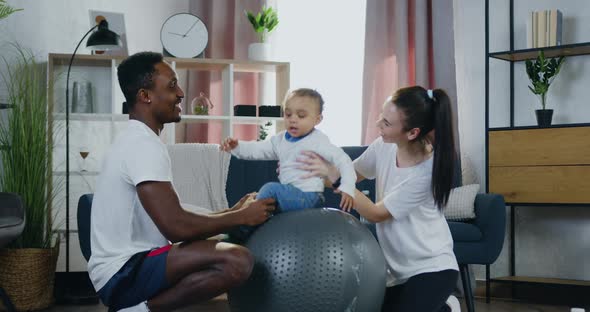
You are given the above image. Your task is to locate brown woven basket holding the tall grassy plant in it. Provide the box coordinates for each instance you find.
[0,244,59,311]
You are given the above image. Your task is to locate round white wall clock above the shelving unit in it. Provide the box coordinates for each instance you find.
[160,13,209,58]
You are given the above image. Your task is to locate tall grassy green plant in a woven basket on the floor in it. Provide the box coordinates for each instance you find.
[0,45,59,311]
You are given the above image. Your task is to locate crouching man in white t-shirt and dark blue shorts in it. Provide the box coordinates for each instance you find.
[88,52,274,311]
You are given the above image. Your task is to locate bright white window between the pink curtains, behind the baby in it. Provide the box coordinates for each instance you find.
[270,0,366,146]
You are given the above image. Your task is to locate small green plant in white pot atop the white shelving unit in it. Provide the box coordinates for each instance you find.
[244,6,279,61]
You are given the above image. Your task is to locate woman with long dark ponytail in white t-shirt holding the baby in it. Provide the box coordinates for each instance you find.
[301,86,458,312]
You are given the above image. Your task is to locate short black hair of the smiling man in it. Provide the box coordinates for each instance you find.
[117,52,164,109]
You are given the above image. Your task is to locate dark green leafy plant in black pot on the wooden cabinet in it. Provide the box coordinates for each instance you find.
[525,50,565,127]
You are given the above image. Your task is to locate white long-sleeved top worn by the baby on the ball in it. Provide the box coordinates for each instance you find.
[232,129,356,198]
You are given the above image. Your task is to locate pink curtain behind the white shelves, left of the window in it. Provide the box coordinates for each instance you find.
[180,0,264,143]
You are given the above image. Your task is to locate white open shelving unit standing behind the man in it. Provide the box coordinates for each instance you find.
[48,54,289,271]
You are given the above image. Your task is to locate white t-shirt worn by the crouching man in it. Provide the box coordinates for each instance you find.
[88,120,172,290]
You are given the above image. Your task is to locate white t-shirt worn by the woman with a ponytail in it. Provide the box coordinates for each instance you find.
[354,137,458,286]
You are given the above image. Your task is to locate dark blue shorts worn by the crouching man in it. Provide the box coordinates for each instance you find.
[98,245,172,311]
